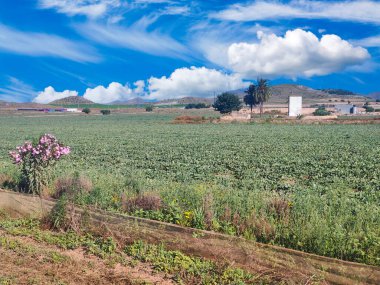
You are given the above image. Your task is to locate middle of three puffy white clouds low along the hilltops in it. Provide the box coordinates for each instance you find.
[83,80,145,104]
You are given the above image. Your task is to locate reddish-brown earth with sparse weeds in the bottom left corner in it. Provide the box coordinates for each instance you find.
[0,230,173,285]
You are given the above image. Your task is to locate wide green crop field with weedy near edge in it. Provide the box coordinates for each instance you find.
[0,114,380,265]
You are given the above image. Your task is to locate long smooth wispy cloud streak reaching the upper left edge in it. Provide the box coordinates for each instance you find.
[0,24,99,62]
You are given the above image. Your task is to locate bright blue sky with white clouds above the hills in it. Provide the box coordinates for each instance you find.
[0,0,380,104]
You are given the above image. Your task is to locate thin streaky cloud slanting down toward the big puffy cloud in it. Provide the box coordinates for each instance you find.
[77,22,189,59]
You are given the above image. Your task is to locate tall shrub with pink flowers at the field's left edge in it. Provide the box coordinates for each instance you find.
[9,134,70,194]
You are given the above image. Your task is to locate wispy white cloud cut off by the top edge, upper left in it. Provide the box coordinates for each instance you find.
[39,0,121,18]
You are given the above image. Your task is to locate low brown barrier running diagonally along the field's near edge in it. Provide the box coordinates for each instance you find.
[0,190,380,285]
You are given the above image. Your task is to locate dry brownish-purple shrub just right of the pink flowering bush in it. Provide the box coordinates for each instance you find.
[52,173,92,199]
